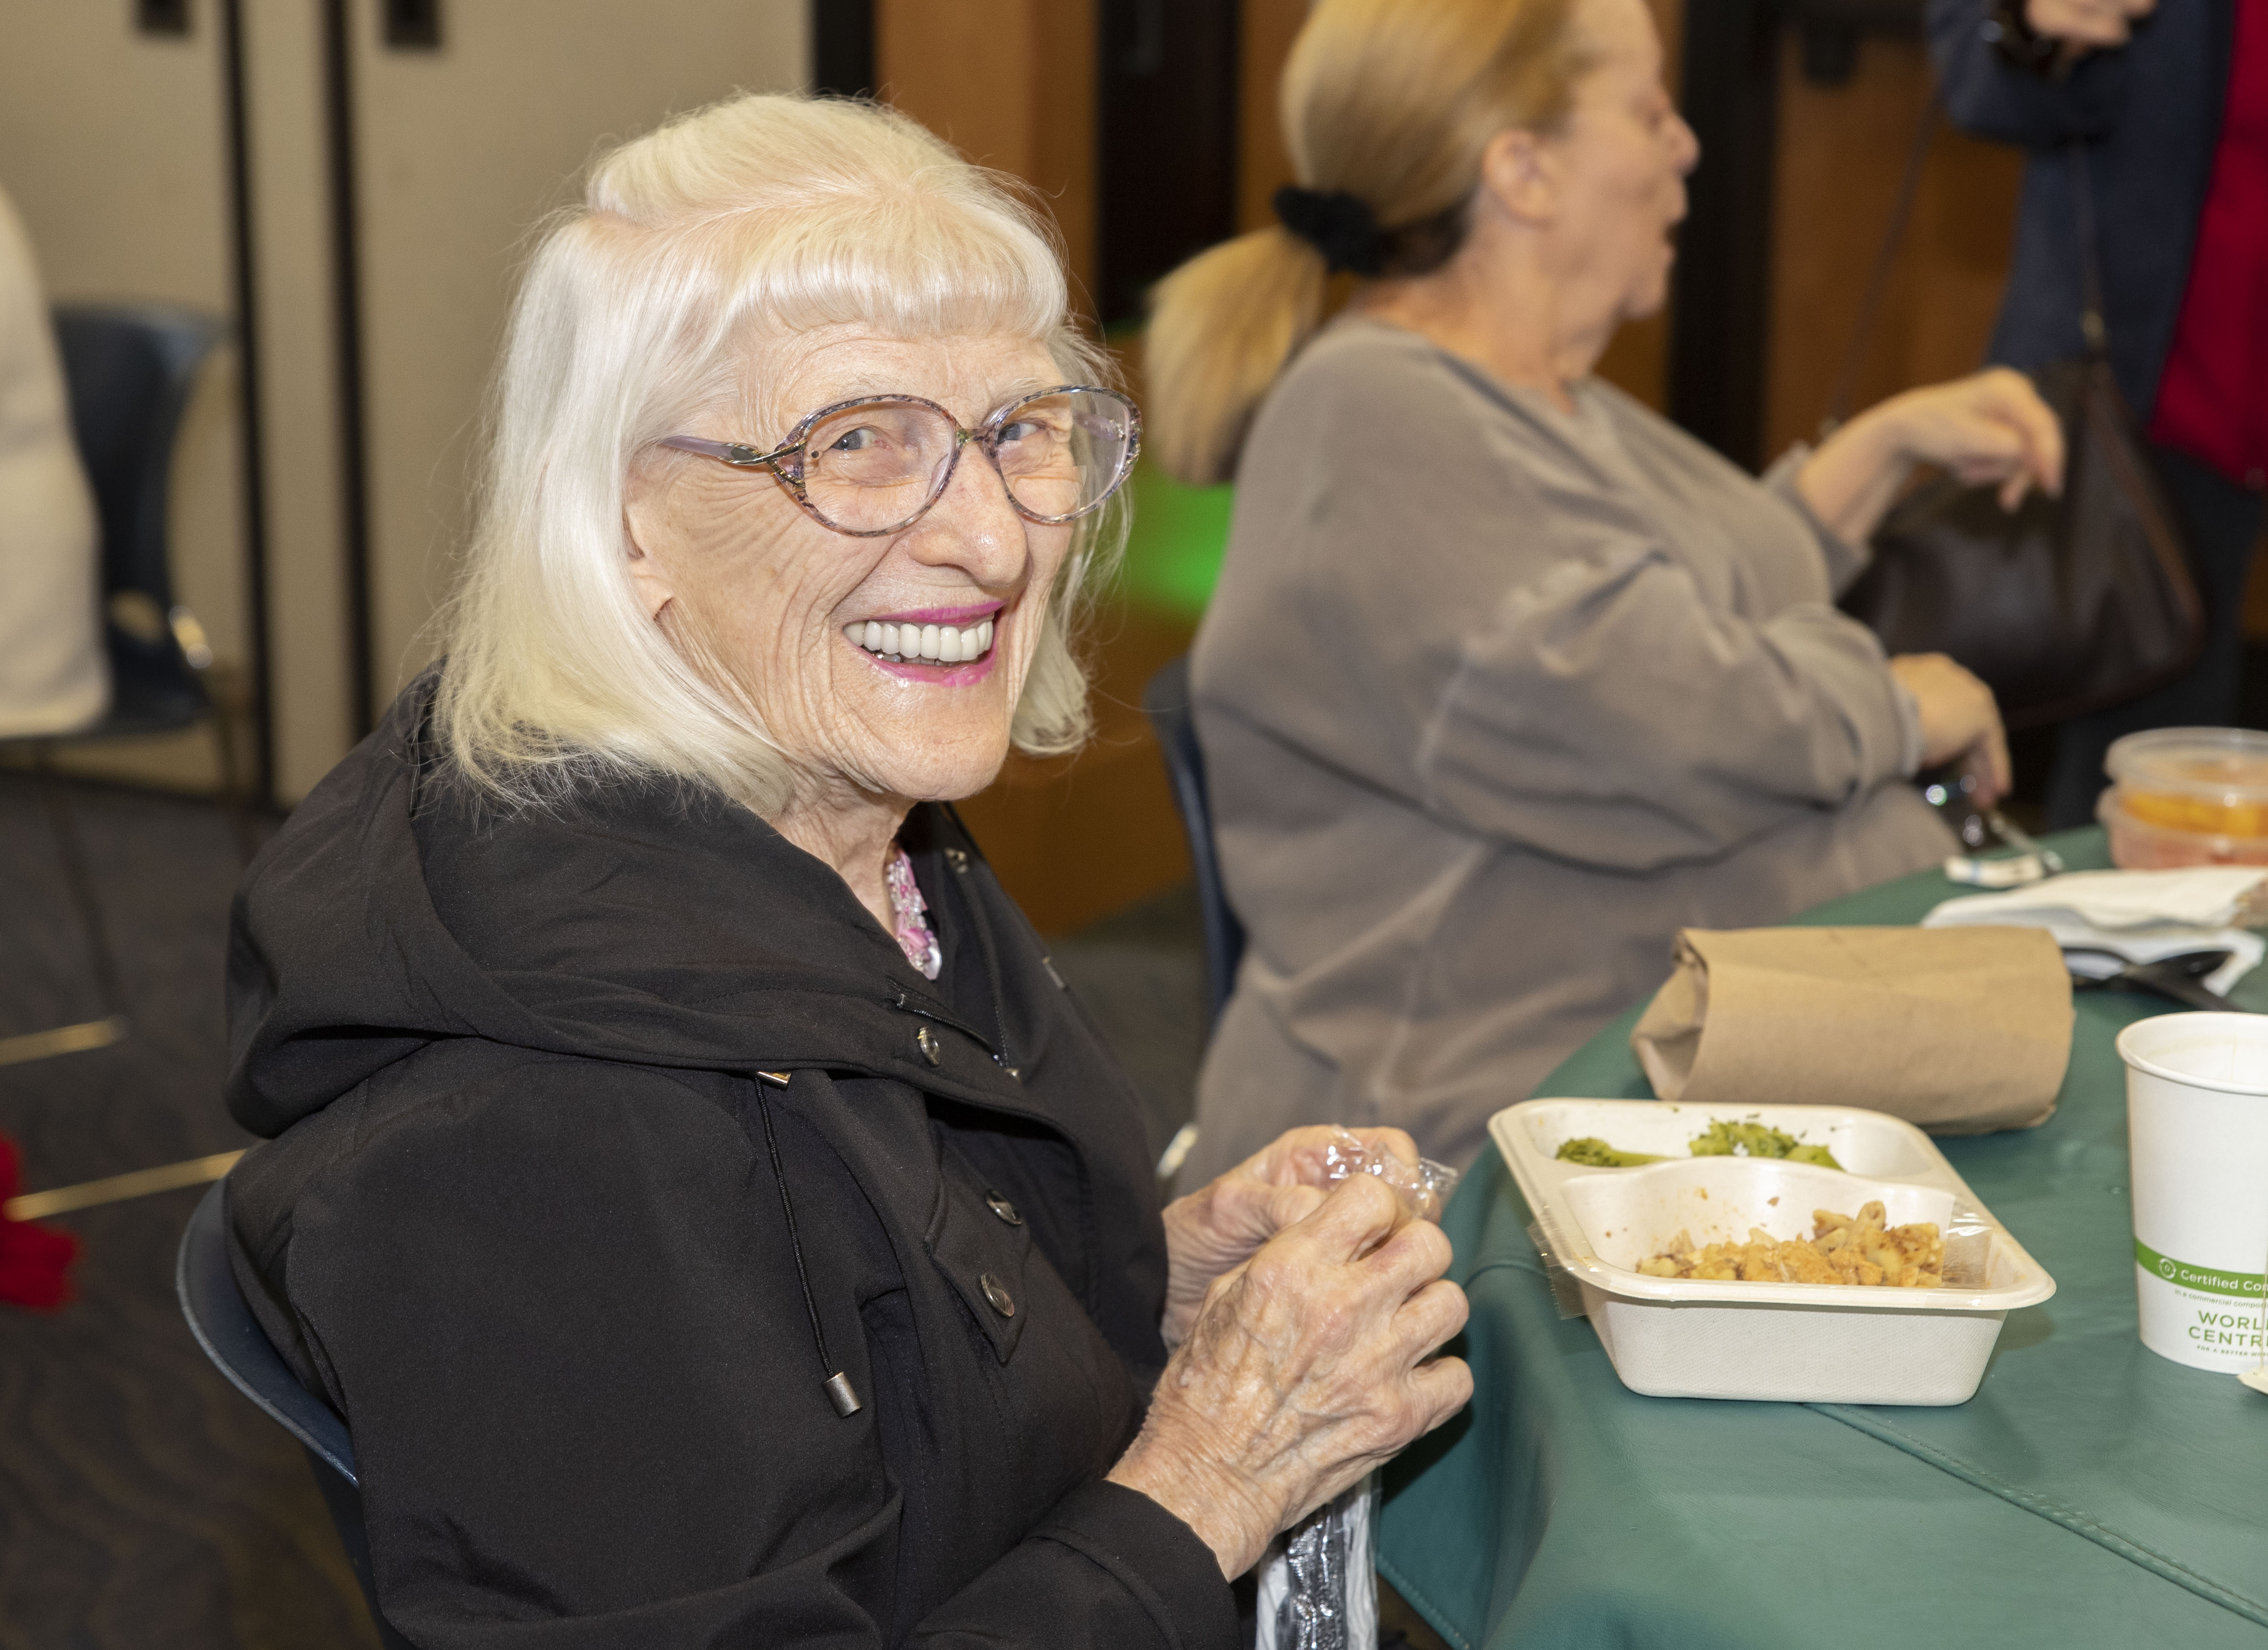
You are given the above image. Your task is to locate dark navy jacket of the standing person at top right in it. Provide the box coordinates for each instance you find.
[1930,0,2236,426]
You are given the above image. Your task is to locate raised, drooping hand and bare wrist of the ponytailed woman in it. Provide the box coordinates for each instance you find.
[1796,367,2064,544]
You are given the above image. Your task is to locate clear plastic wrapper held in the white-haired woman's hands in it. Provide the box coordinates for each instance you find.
[1254,1128,1456,1650]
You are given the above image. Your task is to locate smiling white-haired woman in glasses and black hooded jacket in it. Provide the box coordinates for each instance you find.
[229,97,1470,1650]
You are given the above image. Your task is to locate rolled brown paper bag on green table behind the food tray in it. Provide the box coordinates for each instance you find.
[1631,927,2071,1133]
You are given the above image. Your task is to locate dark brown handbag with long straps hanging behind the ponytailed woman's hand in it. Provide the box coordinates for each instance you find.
[1826,113,2205,730]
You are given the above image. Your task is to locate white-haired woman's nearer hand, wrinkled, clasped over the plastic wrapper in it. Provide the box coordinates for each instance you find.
[1111,1179,1472,1580]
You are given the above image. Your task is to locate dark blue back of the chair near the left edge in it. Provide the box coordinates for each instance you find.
[54,304,227,732]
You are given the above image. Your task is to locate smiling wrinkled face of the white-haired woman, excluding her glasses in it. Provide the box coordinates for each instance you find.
[626,329,1075,800]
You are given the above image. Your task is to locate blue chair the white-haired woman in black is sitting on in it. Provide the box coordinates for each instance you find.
[172,1181,415,1650]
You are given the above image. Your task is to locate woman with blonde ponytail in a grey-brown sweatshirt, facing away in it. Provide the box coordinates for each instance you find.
[1150,0,2062,1181]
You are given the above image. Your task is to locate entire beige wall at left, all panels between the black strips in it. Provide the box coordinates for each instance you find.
[0,0,823,800]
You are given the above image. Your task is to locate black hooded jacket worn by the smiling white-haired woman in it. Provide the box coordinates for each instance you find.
[229,678,1236,1650]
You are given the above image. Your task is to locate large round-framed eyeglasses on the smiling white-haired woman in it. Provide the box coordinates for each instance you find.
[660,383,1141,539]
